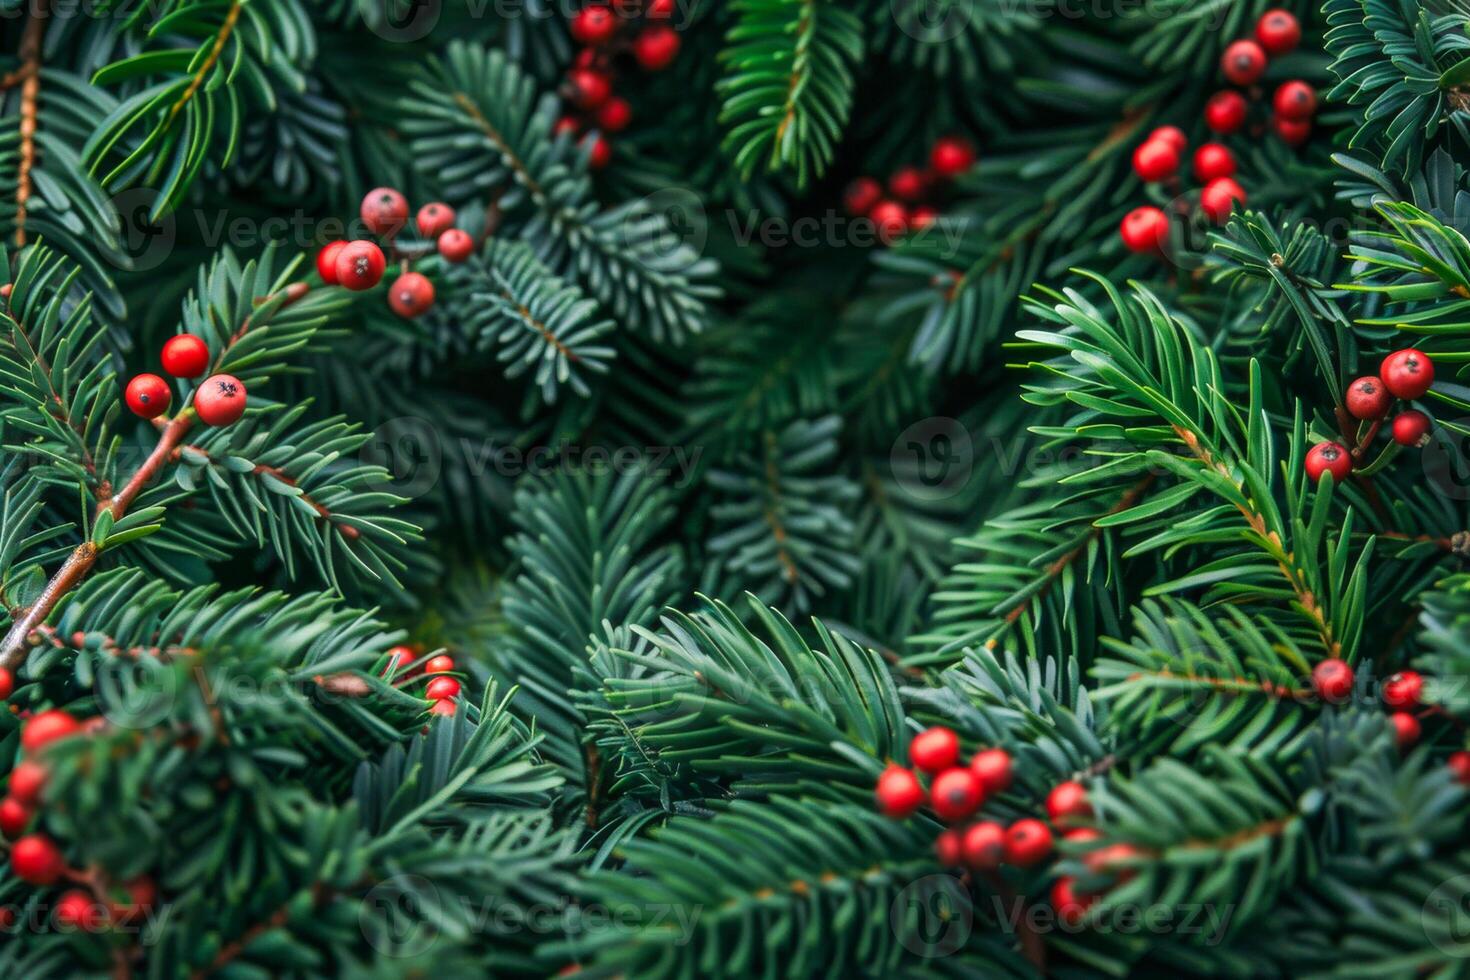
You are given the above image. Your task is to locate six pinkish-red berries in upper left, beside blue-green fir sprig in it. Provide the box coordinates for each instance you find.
[316,187,475,319]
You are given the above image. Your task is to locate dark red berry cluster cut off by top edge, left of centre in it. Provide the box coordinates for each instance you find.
[556,0,681,170]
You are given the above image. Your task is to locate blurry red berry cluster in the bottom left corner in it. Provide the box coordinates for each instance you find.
[0,710,157,932]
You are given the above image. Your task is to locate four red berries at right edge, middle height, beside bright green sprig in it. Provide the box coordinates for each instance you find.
[1305,348,1435,483]
